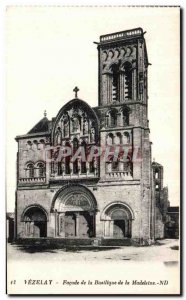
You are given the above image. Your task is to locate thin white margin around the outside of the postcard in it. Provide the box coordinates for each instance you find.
[0,0,186,299]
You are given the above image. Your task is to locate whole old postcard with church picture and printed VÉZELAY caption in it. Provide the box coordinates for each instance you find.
[5,6,181,295]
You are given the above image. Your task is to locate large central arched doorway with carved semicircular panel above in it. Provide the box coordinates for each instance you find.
[52,185,97,238]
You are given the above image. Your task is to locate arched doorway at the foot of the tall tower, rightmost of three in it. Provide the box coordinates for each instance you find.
[101,202,133,239]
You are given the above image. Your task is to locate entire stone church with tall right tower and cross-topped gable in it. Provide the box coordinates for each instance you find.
[15,28,168,244]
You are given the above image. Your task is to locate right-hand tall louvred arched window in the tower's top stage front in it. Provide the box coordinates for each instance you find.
[123,62,132,99]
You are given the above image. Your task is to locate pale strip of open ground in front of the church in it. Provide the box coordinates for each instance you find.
[7,239,179,264]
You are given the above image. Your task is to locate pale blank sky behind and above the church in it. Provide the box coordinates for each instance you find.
[5,6,180,211]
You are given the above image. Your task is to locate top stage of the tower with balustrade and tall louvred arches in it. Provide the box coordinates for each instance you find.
[98,28,148,106]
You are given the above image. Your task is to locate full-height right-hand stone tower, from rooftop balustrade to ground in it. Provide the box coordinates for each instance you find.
[96,28,154,240]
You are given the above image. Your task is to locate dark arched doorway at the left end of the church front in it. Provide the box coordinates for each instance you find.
[22,206,47,238]
